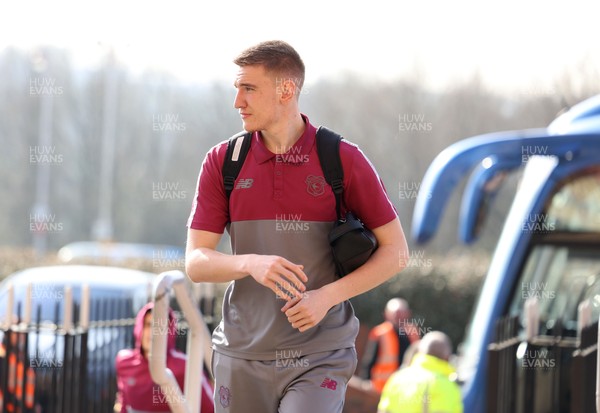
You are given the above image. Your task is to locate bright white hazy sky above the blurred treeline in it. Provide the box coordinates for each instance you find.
[0,0,600,90]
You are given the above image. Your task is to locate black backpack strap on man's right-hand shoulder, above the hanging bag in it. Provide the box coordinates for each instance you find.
[316,126,344,219]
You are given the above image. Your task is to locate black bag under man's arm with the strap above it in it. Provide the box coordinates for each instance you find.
[317,126,377,277]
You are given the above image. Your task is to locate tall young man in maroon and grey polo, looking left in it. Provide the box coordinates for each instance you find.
[186,41,408,413]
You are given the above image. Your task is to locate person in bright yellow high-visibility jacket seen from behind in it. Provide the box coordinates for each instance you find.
[377,331,463,413]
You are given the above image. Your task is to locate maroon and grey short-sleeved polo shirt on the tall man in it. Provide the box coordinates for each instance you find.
[188,115,397,360]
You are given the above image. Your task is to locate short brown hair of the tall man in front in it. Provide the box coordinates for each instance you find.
[233,40,305,89]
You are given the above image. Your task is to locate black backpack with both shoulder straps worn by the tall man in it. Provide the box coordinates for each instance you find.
[222,126,377,277]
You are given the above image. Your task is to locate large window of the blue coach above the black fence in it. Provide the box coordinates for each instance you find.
[509,169,600,336]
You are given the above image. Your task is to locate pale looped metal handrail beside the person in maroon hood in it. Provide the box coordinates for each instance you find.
[149,271,210,413]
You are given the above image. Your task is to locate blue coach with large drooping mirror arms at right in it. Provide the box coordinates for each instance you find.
[412,95,600,413]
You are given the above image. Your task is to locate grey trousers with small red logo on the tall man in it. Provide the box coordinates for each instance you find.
[212,348,357,413]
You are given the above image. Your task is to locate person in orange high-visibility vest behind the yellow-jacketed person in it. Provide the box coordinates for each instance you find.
[359,298,420,393]
